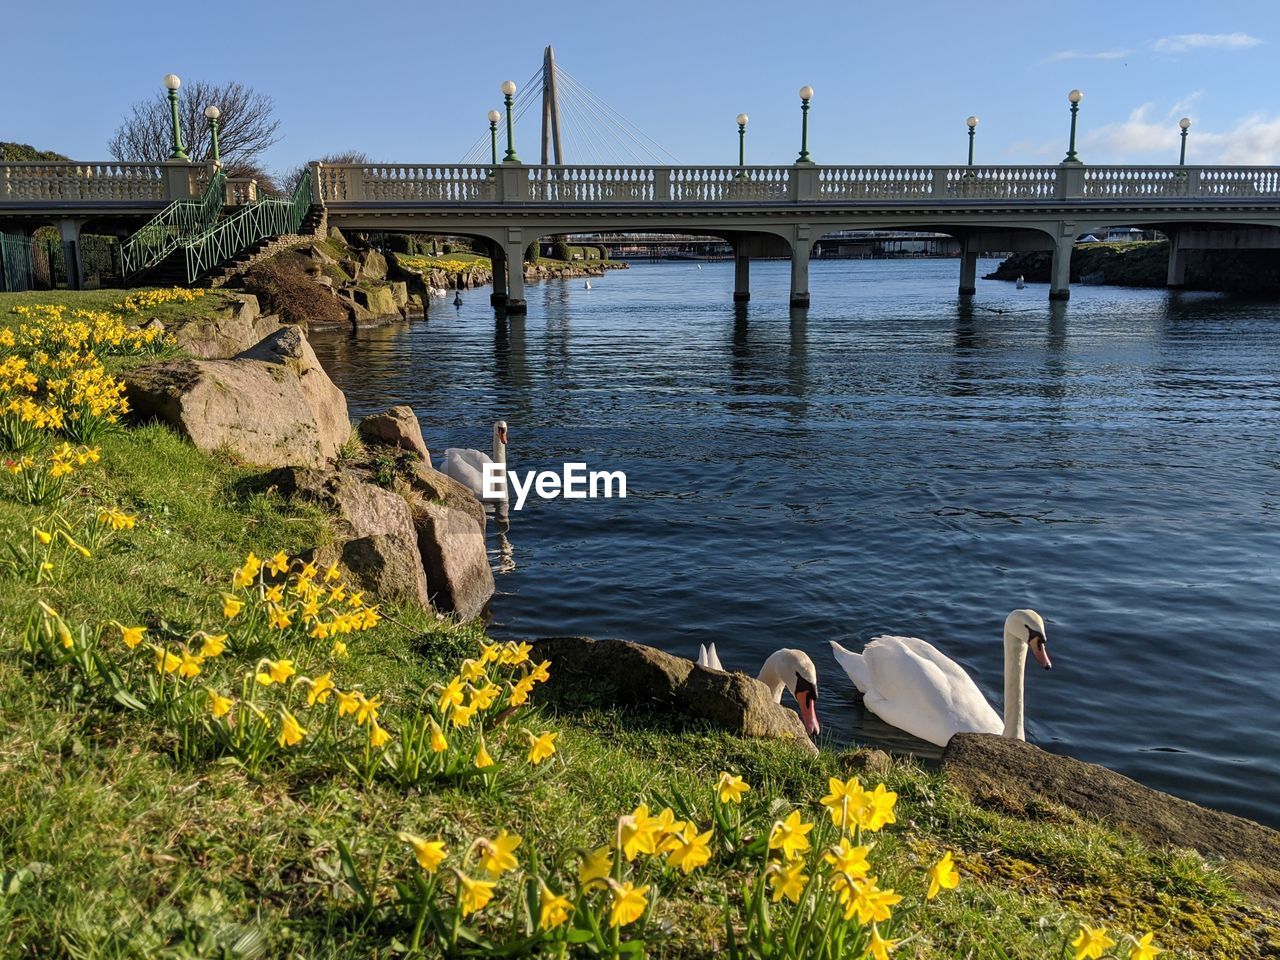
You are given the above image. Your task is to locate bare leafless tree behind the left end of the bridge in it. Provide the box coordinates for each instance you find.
[108,81,280,177]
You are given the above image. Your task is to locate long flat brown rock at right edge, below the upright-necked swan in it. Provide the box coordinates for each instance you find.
[942,733,1280,902]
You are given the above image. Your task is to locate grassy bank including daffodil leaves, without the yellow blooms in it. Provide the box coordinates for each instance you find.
[0,293,1280,959]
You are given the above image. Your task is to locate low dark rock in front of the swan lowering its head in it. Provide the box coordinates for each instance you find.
[534,636,817,753]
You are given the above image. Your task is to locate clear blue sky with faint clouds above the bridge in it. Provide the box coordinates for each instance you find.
[0,0,1280,169]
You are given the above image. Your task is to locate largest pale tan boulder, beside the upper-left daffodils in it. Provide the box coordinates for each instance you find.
[124,326,351,467]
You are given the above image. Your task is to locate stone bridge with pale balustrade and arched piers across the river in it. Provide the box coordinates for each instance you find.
[0,161,1280,314]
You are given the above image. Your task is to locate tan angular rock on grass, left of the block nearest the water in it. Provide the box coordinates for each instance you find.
[268,467,429,607]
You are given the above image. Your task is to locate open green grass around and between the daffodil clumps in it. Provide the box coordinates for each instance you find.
[0,294,1280,960]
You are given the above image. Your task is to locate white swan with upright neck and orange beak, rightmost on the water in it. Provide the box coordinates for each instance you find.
[831,611,1053,746]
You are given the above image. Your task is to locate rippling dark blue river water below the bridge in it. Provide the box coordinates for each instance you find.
[314,260,1280,826]
